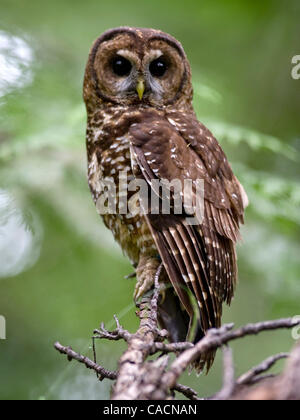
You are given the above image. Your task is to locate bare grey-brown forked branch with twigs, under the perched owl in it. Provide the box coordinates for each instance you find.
[55,265,300,400]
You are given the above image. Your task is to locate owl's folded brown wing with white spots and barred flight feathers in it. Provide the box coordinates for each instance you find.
[130,112,244,338]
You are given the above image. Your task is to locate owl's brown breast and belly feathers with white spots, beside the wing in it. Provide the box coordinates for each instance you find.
[86,107,158,265]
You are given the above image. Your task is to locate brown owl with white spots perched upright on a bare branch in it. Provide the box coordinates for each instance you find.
[83,27,247,370]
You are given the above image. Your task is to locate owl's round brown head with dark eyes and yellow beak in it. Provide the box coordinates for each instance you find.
[83,27,192,108]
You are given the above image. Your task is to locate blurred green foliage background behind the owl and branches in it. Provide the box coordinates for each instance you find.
[0,0,300,399]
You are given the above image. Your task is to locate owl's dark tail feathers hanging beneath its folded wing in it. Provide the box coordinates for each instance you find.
[158,287,216,374]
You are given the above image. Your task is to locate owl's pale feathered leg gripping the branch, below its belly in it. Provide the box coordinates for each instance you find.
[133,257,160,302]
